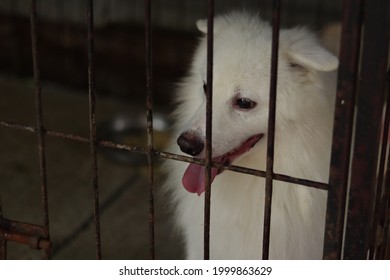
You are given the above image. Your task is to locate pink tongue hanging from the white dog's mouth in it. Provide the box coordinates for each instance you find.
[182,163,218,195]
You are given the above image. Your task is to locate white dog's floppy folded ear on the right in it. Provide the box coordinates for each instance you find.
[283,28,339,72]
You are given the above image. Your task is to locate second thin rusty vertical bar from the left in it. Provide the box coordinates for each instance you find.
[87,0,102,260]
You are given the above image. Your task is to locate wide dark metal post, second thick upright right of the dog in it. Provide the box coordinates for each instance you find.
[344,1,390,259]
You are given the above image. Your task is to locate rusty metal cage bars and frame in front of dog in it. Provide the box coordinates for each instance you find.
[0,0,390,259]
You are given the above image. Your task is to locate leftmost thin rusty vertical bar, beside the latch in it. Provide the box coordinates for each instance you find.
[30,0,51,259]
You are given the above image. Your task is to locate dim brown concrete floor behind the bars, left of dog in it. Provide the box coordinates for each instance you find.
[0,77,183,259]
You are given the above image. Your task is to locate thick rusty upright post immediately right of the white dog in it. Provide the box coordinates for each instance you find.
[323,0,364,259]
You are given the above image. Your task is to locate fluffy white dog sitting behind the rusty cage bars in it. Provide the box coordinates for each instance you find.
[167,12,338,259]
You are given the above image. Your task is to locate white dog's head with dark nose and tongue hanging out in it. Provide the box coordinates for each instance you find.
[177,13,338,194]
